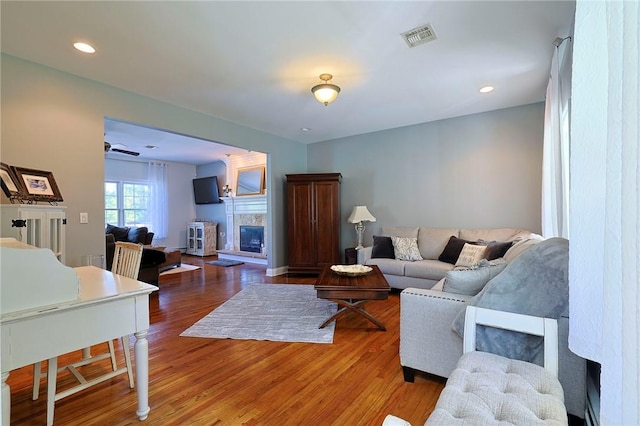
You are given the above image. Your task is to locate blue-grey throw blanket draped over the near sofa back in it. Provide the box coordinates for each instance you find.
[453,238,569,363]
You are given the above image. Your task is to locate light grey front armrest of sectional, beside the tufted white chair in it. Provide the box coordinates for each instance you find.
[400,288,472,377]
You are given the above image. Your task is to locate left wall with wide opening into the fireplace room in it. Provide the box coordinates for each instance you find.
[0,54,307,268]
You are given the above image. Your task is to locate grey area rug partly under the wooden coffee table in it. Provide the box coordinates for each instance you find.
[181,284,337,343]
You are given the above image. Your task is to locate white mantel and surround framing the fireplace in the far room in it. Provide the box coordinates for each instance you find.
[218,195,267,264]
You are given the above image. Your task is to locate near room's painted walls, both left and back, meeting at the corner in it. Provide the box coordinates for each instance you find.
[0,55,544,269]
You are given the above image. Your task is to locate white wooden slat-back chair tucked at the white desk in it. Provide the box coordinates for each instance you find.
[33,242,143,425]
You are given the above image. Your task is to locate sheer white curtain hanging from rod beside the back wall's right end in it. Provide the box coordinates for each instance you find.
[542,38,572,238]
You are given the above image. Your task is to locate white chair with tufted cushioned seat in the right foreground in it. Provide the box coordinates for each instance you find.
[425,306,568,426]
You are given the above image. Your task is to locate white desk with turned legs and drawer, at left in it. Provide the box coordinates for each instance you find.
[0,266,158,425]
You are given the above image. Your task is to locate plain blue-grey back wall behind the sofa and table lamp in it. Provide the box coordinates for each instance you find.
[307,103,544,247]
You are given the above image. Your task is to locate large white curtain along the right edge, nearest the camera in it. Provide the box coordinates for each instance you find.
[569,0,640,425]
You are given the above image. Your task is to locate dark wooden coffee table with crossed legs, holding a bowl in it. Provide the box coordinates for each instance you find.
[315,265,391,331]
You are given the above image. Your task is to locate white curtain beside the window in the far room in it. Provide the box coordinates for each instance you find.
[147,161,169,244]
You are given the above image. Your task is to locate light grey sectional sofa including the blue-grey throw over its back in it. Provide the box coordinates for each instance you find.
[358,227,586,418]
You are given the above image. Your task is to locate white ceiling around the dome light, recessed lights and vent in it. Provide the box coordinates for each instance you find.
[0,0,575,165]
